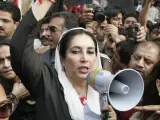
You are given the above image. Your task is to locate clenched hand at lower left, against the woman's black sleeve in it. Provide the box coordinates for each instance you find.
[12,83,30,100]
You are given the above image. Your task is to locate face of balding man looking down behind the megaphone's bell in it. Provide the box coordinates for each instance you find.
[129,46,159,78]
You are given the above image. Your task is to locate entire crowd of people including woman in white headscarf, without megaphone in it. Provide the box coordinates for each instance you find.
[0,0,160,120]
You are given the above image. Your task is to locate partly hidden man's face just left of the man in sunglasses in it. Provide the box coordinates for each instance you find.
[40,23,50,46]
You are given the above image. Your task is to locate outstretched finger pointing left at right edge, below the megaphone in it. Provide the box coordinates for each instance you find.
[135,105,160,111]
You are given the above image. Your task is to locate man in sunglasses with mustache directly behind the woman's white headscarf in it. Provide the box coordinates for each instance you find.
[41,12,79,65]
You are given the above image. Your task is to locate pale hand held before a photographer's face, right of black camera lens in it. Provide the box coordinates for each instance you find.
[104,24,120,43]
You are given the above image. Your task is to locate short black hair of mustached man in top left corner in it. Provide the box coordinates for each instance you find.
[0,1,21,22]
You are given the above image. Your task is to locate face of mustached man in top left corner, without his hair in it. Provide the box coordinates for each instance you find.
[0,10,18,38]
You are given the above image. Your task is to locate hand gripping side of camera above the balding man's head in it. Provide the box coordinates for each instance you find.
[136,26,146,42]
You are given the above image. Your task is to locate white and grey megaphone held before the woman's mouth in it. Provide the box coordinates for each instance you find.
[86,69,144,111]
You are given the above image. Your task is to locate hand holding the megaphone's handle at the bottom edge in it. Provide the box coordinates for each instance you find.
[101,105,117,120]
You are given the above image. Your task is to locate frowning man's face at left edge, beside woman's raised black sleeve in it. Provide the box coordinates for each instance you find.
[0,45,16,80]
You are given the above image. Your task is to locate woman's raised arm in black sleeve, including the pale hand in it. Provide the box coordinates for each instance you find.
[10,0,52,94]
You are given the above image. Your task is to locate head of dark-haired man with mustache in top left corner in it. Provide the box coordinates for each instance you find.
[0,1,21,39]
